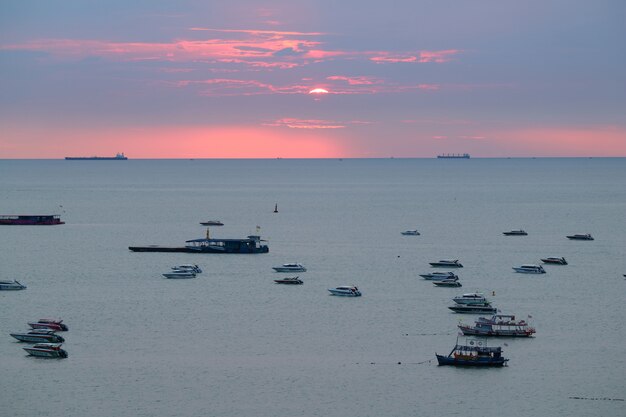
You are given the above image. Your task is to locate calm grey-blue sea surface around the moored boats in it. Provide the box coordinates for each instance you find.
[0,158,626,417]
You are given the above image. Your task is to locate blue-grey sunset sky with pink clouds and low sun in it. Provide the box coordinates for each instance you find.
[0,0,626,159]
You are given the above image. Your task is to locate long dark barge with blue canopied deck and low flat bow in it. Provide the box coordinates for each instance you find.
[128,235,269,253]
